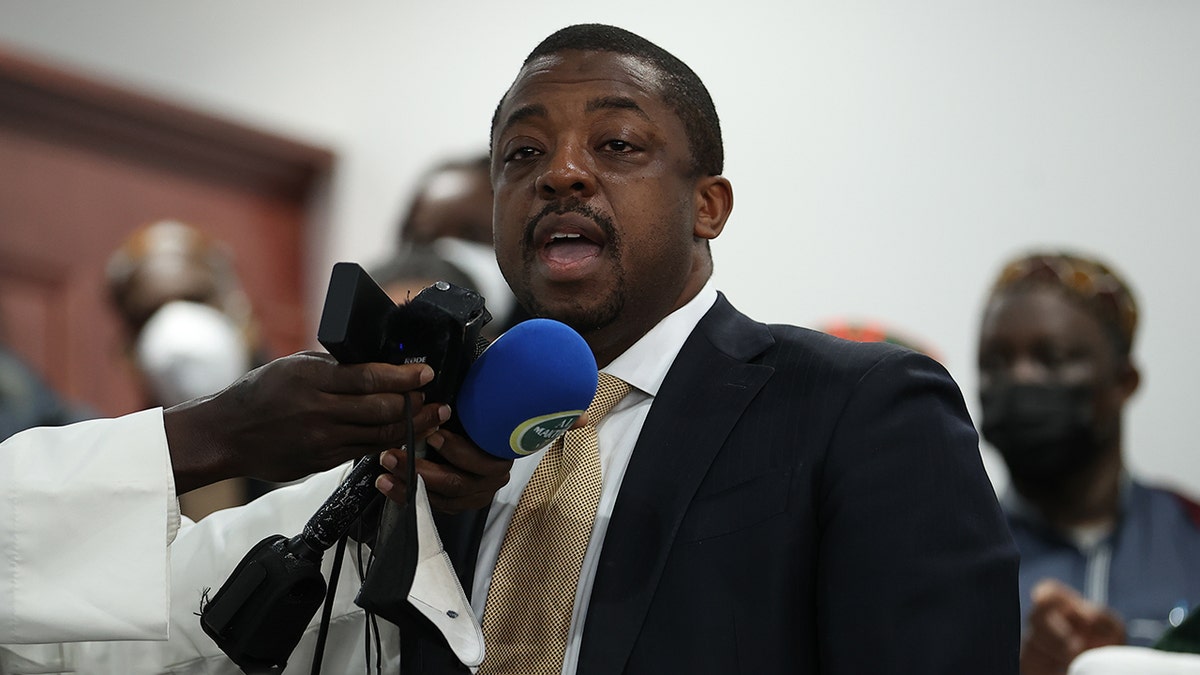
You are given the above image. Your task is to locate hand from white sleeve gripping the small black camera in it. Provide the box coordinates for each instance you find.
[163,352,449,494]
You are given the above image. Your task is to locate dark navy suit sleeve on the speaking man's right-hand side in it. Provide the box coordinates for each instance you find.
[816,352,1020,675]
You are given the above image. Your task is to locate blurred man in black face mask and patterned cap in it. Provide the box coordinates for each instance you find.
[978,253,1200,675]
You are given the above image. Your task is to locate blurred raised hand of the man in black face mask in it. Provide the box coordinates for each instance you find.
[1021,579,1126,675]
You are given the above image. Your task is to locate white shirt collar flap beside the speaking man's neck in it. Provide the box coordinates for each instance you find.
[601,279,716,396]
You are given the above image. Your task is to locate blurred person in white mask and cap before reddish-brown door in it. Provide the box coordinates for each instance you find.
[106,220,268,519]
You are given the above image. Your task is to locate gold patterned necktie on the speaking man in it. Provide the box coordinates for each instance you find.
[479,372,630,675]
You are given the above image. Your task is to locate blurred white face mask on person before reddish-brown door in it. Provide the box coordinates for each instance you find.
[134,300,250,407]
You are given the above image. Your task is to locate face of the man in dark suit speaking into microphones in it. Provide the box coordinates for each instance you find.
[492,50,724,362]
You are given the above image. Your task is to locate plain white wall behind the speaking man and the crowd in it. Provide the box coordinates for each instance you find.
[0,0,1200,494]
